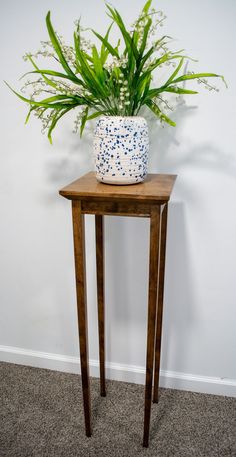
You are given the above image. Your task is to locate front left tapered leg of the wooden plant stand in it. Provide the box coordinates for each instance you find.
[72,200,91,436]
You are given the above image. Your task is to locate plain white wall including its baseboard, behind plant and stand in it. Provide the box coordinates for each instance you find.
[0,0,236,395]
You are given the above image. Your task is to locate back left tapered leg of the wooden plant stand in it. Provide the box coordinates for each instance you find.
[95,215,106,397]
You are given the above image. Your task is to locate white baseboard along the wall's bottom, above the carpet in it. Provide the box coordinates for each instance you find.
[0,346,236,397]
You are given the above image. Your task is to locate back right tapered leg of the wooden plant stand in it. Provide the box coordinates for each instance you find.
[153,203,168,403]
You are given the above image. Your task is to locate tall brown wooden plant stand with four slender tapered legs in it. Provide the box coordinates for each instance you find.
[59,172,176,447]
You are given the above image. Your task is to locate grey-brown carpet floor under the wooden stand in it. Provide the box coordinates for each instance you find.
[0,363,236,457]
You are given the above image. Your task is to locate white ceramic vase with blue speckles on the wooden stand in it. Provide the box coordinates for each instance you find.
[94,116,149,185]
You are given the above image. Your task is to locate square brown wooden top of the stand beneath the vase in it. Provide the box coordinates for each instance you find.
[59,171,177,202]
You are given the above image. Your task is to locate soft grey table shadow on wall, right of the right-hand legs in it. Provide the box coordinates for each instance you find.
[162,202,197,371]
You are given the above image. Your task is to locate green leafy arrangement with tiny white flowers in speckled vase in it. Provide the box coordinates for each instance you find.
[6,0,224,142]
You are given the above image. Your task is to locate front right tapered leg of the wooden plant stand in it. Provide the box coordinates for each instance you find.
[143,206,160,447]
